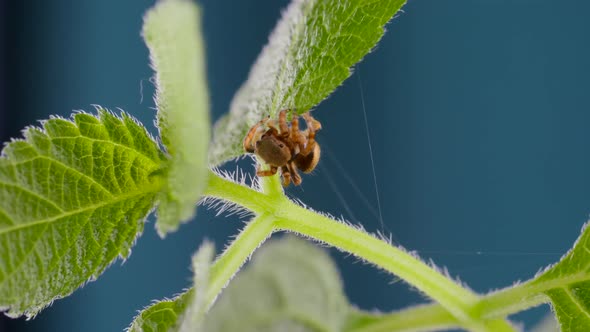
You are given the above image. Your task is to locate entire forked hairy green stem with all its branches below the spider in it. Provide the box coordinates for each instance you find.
[205,174,514,332]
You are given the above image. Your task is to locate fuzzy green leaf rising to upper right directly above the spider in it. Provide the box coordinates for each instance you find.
[209,0,405,165]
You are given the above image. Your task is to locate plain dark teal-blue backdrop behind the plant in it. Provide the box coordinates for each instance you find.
[0,0,590,331]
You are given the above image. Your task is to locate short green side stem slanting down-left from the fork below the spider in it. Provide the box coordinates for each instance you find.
[205,215,274,307]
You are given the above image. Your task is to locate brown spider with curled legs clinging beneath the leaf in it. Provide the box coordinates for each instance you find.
[244,110,322,186]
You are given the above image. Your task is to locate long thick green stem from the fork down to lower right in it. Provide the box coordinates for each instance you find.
[275,199,513,332]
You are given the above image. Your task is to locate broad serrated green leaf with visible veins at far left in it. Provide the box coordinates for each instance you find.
[0,109,164,317]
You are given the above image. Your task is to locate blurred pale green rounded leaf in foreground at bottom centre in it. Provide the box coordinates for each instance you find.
[204,237,349,332]
